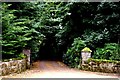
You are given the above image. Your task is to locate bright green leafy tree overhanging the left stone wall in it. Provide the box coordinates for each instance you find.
[2,3,44,58]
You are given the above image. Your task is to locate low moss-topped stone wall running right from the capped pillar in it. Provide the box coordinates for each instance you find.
[81,59,120,74]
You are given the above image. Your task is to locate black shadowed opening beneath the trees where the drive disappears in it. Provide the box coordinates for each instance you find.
[38,34,62,60]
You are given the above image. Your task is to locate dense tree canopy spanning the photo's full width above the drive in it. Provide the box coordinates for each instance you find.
[2,2,120,62]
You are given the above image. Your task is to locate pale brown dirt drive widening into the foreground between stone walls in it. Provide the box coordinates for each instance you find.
[2,61,119,78]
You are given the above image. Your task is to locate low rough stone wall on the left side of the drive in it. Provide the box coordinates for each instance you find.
[0,59,27,76]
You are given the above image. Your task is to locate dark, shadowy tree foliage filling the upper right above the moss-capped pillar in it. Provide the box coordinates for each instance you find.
[61,2,120,55]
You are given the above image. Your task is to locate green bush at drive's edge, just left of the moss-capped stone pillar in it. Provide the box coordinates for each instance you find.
[63,37,86,67]
